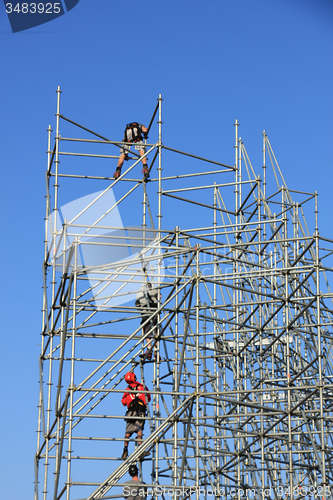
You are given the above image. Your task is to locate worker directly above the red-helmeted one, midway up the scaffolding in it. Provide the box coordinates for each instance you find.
[135,282,159,361]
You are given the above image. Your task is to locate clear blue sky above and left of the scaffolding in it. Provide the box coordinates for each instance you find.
[0,0,333,500]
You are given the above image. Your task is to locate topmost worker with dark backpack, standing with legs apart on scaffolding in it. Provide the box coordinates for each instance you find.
[113,122,149,179]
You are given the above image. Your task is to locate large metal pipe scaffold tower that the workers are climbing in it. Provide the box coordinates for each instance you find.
[35,88,333,500]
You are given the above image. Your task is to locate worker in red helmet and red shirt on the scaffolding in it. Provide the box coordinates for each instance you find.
[121,372,150,460]
